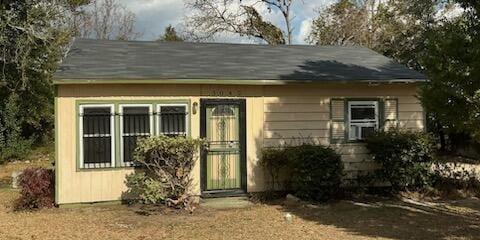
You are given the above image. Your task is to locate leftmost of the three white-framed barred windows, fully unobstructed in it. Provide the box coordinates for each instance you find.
[79,104,115,168]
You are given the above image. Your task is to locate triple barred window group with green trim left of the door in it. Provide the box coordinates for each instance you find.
[78,102,189,169]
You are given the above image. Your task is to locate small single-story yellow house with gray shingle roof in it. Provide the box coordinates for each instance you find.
[54,39,426,204]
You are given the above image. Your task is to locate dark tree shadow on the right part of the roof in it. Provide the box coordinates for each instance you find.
[280,59,422,80]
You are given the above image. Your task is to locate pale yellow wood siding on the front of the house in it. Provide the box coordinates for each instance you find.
[56,84,424,204]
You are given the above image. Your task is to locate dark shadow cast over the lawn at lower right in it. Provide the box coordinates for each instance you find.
[268,199,480,240]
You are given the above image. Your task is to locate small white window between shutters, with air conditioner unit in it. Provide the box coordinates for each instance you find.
[348,101,378,140]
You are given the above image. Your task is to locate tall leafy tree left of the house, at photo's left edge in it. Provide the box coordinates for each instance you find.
[0,0,76,162]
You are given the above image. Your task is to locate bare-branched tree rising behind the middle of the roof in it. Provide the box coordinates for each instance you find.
[185,0,294,44]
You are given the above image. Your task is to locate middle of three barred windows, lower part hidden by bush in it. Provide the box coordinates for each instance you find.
[120,104,153,166]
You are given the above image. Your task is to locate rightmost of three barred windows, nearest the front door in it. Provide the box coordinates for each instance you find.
[157,104,187,136]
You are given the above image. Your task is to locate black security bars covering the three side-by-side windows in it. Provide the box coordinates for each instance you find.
[80,106,188,169]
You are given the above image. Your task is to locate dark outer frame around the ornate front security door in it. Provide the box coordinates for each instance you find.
[200,98,247,197]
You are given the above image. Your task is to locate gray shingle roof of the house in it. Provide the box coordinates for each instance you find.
[54,39,425,82]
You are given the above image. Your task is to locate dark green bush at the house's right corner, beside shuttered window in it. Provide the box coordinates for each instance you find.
[366,129,434,191]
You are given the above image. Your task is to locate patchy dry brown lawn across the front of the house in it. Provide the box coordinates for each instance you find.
[0,190,480,240]
